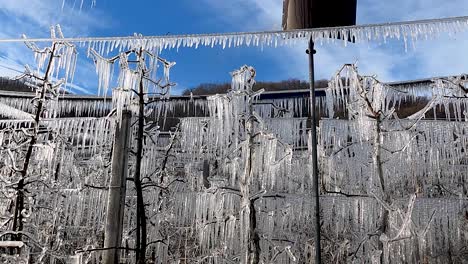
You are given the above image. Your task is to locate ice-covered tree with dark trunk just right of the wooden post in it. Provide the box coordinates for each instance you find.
[92,47,176,263]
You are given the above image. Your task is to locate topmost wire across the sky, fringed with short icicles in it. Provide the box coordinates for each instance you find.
[0,16,468,53]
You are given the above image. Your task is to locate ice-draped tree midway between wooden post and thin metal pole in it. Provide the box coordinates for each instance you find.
[181,66,310,263]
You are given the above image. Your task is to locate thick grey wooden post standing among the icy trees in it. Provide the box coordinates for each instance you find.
[103,111,132,264]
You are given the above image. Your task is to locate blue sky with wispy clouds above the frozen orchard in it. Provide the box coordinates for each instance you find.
[0,0,468,93]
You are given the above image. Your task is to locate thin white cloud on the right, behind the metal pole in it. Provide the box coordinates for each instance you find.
[203,0,468,81]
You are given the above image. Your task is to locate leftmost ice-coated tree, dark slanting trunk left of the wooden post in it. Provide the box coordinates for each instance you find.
[2,26,76,256]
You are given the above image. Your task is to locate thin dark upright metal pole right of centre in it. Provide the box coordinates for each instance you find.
[307,37,322,264]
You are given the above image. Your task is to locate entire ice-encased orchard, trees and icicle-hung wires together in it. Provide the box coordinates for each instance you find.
[0,8,468,264]
